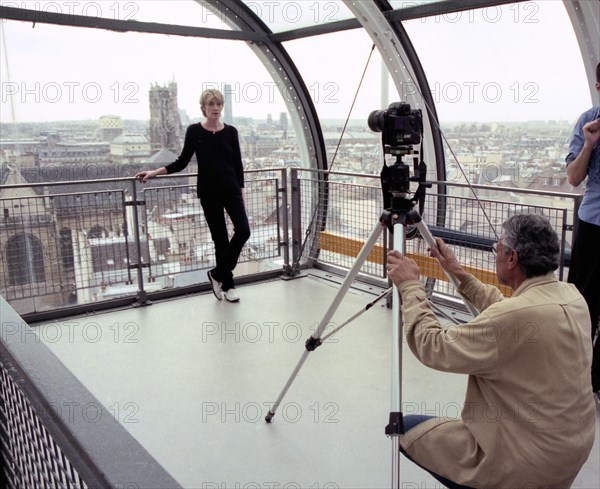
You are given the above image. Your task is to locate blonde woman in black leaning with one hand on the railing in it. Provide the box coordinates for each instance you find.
[135,89,250,302]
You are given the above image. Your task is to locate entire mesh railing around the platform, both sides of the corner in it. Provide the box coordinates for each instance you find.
[0,168,579,320]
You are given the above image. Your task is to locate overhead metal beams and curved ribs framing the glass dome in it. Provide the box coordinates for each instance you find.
[0,0,600,172]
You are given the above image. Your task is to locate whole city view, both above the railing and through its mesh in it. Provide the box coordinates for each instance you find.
[0,81,584,311]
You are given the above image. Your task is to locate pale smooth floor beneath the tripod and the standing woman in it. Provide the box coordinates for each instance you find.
[36,276,600,489]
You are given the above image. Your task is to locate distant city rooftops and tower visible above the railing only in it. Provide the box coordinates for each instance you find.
[0,82,584,193]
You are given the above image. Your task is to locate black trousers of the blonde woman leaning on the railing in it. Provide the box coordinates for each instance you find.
[200,193,250,290]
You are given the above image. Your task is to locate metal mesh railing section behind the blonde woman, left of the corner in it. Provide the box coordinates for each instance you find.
[0,169,289,320]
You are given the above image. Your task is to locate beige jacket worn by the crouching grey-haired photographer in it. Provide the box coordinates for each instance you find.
[399,273,595,489]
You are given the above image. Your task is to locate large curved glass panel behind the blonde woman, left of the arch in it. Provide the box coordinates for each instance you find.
[0,21,305,312]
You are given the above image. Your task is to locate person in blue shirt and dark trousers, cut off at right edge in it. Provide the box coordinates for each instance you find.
[565,63,600,399]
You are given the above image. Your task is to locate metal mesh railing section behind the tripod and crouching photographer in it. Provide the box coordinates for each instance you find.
[292,169,581,297]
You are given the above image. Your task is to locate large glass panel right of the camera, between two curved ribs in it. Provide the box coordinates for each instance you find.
[403,2,593,207]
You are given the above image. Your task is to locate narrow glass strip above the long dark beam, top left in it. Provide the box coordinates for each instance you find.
[3,0,229,29]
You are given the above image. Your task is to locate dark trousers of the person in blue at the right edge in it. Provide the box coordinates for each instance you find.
[568,221,600,392]
